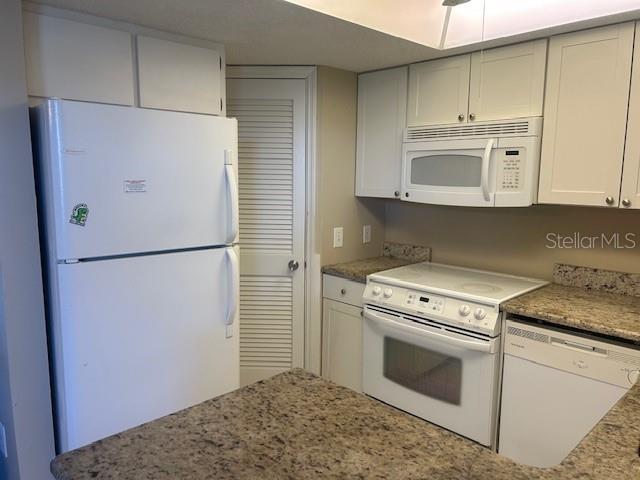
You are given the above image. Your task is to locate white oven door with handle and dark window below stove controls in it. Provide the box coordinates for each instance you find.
[363,306,499,446]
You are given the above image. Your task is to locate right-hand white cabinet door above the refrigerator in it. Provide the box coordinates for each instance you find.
[137,36,222,115]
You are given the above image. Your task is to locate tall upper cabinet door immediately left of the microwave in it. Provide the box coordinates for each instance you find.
[356,67,407,198]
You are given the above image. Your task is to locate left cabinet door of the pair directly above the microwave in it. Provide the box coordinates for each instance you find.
[407,55,471,127]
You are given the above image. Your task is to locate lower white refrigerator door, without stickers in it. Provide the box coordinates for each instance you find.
[52,248,239,451]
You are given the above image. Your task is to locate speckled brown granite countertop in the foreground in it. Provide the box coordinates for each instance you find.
[51,369,640,480]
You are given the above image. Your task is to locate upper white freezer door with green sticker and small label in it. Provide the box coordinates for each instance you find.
[42,100,237,260]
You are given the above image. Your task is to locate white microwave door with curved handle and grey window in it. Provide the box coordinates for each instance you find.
[401,138,498,207]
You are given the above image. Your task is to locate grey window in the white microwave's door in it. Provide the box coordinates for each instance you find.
[411,154,482,187]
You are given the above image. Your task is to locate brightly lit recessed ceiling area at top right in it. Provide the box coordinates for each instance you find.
[286,0,640,49]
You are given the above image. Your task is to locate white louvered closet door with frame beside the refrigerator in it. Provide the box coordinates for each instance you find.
[227,79,306,385]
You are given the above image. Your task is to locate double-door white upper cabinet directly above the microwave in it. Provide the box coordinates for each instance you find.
[407,39,547,127]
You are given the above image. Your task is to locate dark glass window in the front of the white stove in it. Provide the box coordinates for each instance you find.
[384,337,462,405]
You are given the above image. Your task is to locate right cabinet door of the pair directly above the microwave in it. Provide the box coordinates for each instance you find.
[469,39,547,121]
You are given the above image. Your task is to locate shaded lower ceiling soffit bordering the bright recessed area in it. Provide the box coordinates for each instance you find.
[27,0,637,72]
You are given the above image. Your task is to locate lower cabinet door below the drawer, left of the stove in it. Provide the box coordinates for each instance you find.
[322,298,362,392]
